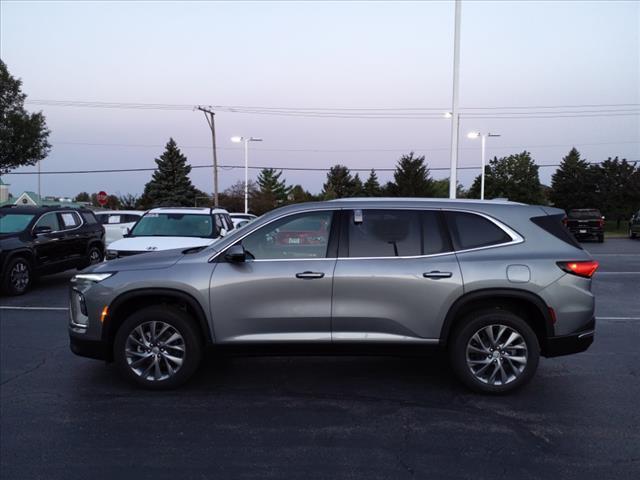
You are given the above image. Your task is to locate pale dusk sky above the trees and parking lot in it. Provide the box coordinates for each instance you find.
[0,0,640,196]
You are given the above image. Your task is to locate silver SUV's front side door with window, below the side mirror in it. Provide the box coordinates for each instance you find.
[210,210,337,343]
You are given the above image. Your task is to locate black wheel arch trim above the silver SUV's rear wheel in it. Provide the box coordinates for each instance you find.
[440,288,554,346]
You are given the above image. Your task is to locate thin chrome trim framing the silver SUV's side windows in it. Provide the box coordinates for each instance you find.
[208,206,524,262]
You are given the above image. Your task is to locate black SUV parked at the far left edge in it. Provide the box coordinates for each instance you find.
[0,205,104,295]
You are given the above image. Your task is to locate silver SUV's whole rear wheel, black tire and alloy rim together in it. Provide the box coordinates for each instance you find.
[449,309,540,394]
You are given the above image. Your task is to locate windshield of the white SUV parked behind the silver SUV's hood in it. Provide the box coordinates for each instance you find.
[130,213,217,238]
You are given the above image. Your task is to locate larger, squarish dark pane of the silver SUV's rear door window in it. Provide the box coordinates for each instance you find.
[348,210,422,257]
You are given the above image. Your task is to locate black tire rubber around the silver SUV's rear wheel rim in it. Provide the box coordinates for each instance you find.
[449,310,540,395]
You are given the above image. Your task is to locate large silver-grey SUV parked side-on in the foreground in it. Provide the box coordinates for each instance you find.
[69,199,598,393]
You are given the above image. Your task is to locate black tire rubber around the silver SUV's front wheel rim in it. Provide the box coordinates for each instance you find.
[113,306,203,390]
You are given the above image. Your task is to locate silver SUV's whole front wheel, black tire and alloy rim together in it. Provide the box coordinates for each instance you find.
[113,306,203,390]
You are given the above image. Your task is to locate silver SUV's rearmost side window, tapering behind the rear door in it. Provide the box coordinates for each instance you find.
[446,212,511,250]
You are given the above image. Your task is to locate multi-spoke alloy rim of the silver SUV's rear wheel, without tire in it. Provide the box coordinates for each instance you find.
[466,324,528,386]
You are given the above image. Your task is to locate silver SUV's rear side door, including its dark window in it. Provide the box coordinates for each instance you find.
[332,209,463,343]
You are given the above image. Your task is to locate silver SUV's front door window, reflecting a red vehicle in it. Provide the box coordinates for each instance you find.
[242,212,333,260]
